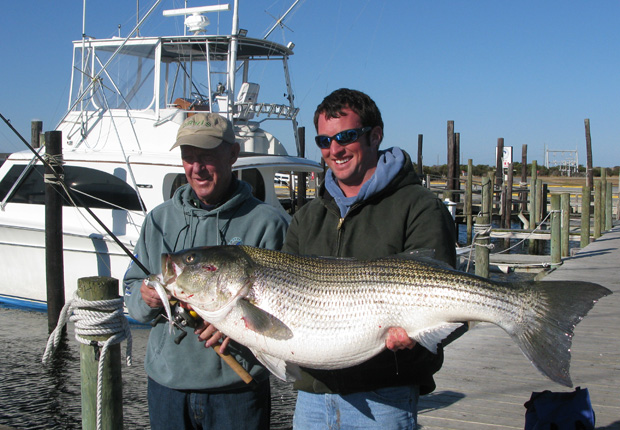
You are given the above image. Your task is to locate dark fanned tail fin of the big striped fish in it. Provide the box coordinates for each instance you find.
[509,281,611,387]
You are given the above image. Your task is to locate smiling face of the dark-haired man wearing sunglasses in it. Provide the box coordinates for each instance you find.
[317,108,383,197]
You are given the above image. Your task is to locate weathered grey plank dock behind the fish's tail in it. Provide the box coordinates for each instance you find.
[418,226,620,430]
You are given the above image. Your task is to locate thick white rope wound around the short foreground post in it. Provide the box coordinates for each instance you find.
[42,292,132,430]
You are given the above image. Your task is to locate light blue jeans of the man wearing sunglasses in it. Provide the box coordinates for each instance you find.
[293,386,420,430]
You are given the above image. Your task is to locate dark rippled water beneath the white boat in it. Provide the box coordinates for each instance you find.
[0,305,296,430]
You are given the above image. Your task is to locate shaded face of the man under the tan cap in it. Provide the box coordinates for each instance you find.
[181,142,240,205]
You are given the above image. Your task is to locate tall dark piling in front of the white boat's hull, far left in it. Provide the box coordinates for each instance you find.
[45,131,65,333]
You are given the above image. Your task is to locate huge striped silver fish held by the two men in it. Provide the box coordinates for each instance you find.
[160,246,611,387]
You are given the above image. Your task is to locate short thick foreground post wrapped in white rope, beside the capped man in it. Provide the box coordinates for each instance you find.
[77,276,123,429]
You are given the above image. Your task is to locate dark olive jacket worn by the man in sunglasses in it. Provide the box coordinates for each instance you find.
[282,152,456,394]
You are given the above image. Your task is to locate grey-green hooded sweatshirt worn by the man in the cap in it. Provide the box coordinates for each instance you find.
[123,181,287,390]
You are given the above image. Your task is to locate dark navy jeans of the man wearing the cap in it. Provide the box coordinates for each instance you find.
[147,378,271,430]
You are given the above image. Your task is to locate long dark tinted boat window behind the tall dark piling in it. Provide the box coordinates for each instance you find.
[0,165,142,211]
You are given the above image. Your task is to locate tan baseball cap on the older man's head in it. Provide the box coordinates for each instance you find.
[170,113,235,150]
